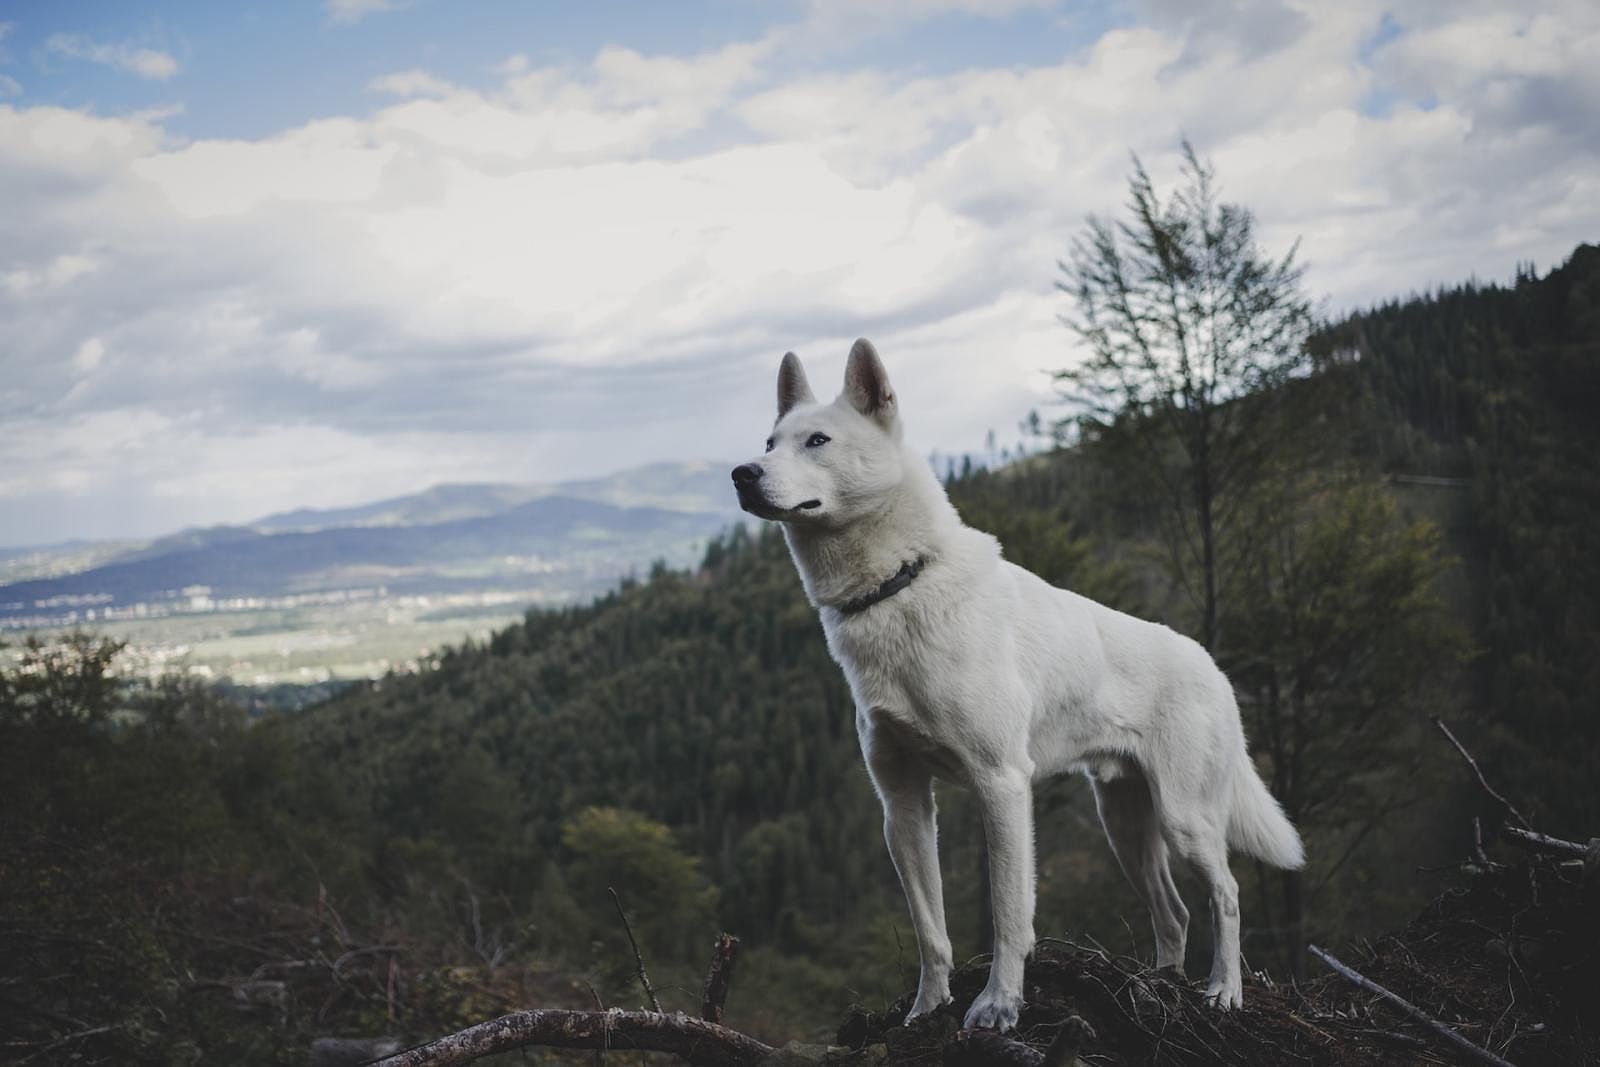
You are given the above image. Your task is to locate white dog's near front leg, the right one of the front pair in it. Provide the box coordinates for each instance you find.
[966,768,1035,1030]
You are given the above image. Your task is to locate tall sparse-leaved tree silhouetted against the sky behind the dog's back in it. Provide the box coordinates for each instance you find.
[1056,141,1312,649]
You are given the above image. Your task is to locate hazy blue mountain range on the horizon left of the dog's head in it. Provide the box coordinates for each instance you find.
[0,464,738,619]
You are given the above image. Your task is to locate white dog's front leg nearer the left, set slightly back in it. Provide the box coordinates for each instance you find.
[867,736,952,1019]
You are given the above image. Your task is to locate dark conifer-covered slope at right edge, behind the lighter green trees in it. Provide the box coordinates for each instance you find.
[1322,245,1600,832]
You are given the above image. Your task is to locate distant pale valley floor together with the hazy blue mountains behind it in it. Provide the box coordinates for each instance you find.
[0,462,736,704]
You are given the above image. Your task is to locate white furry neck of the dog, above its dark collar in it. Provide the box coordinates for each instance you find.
[784,456,962,608]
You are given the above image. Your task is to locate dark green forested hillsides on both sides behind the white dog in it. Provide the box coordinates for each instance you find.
[0,246,1600,1062]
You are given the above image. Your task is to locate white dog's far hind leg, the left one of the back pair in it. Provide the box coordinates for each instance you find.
[1091,766,1189,973]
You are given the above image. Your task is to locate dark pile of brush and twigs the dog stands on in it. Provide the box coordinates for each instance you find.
[827,827,1600,1067]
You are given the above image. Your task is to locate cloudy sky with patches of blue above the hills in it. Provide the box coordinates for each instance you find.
[0,0,1600,545]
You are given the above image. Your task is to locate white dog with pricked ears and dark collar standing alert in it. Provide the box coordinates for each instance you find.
[733,341,1304,1030]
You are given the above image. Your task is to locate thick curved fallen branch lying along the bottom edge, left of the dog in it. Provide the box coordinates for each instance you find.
[374,1008,773,1067]
